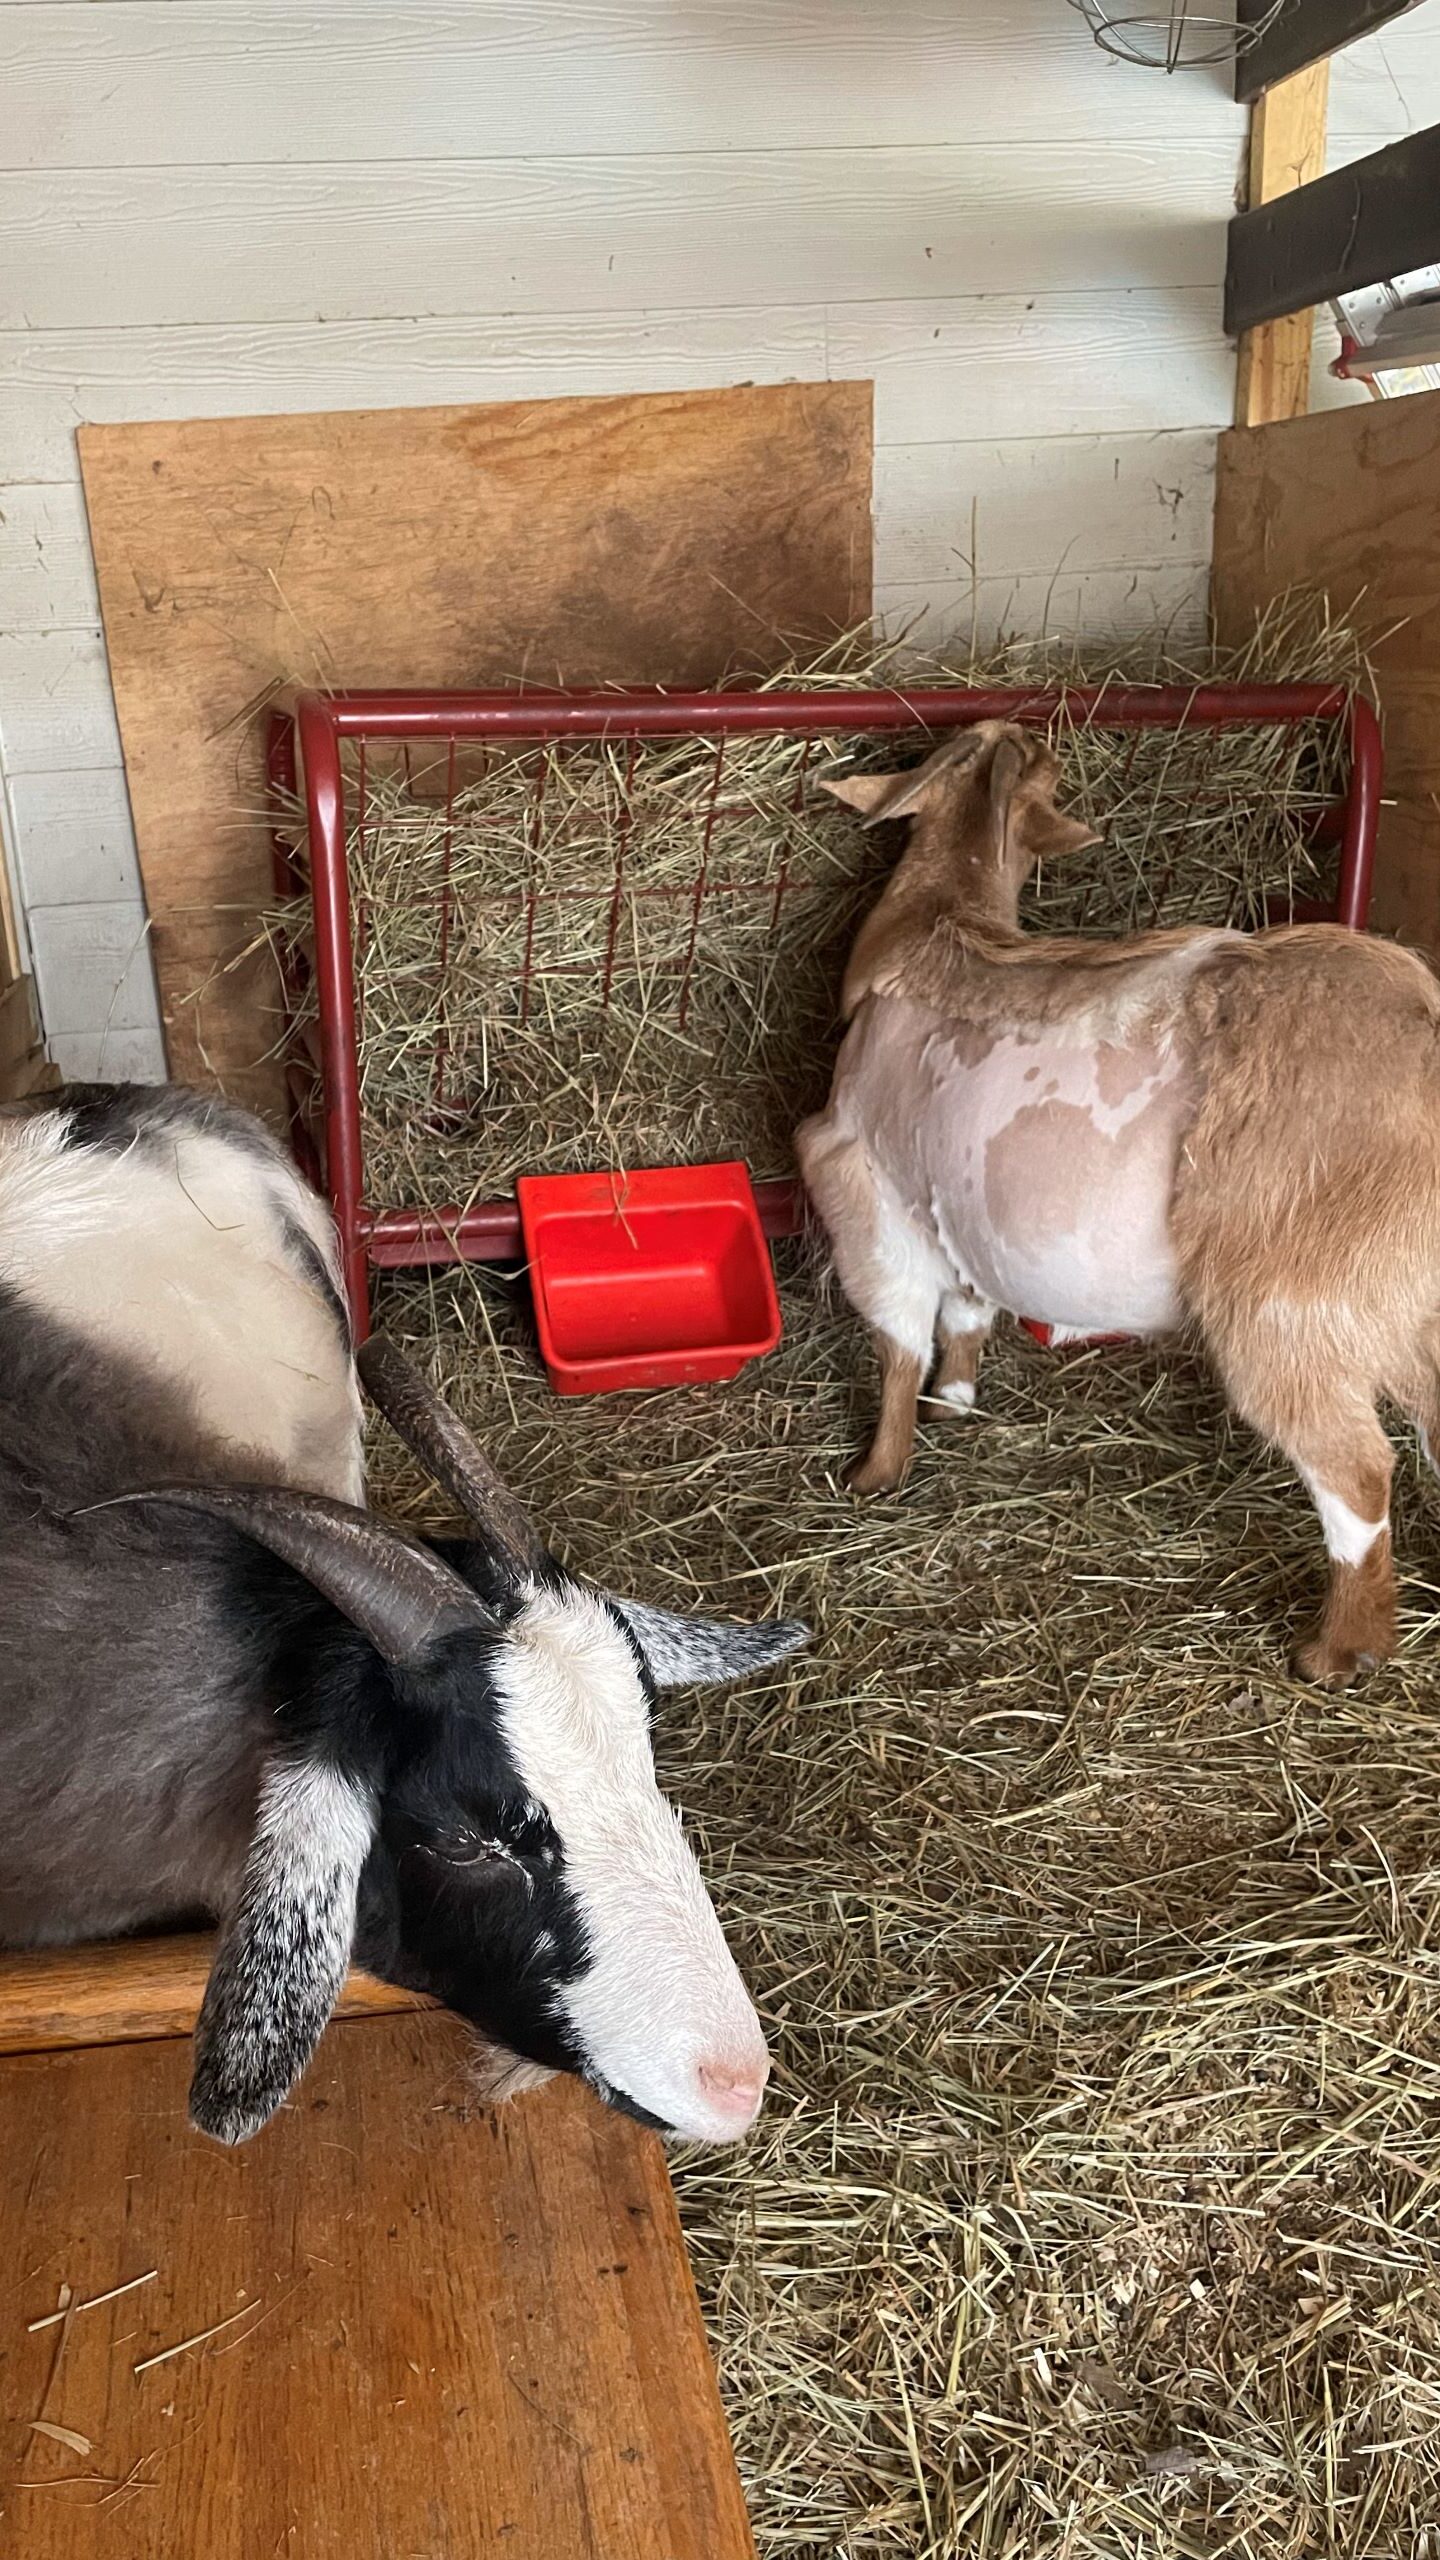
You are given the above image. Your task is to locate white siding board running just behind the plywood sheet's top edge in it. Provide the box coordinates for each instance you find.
[0,293,1232,491]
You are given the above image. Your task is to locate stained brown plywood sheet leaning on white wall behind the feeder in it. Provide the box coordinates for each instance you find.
[79,381,871,1108]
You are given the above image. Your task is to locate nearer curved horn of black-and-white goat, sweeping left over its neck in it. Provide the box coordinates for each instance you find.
[90,1485,497,1664]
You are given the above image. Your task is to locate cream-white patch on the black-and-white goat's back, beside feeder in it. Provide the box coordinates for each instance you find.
[0,1111,364,1503]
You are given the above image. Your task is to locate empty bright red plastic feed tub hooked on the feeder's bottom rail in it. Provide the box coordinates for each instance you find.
[515,1165,779,1395]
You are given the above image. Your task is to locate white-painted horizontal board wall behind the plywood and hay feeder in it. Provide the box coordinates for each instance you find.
[0,0,1245,1075]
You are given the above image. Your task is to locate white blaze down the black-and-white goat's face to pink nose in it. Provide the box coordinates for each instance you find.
[495,1590,769,2143]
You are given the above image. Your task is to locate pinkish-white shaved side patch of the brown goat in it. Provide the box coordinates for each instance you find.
[830,998,1197,1334]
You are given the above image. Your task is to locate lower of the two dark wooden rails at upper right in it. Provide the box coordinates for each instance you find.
[1225,125,1440,338]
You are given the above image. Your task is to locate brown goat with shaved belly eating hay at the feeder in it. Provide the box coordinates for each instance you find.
[797,722,1440,1684]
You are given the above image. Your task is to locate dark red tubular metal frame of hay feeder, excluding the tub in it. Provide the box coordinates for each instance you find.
[266,684,1381,1339]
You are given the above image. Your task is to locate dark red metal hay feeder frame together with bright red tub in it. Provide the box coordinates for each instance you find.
[269,684,1381,1361]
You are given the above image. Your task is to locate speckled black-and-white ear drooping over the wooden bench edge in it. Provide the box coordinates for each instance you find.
[190,1759,377,2143]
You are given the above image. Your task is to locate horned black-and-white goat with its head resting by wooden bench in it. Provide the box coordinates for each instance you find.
[0,1088,805,2143]
